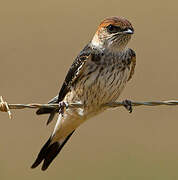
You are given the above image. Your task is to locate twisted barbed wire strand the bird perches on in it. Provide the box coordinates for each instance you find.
[0,96,178,119]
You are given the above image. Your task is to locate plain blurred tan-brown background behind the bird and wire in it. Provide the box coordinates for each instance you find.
[0,0,178,180]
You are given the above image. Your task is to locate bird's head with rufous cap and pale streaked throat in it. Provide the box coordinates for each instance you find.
[91,17,134,51]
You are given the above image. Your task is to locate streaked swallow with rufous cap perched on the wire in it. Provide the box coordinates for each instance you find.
[31,17,136,170]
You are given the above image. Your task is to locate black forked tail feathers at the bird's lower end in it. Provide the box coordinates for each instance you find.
[31,130,75,171]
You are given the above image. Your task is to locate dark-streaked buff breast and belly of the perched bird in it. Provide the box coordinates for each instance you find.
[64,49,136,115]
